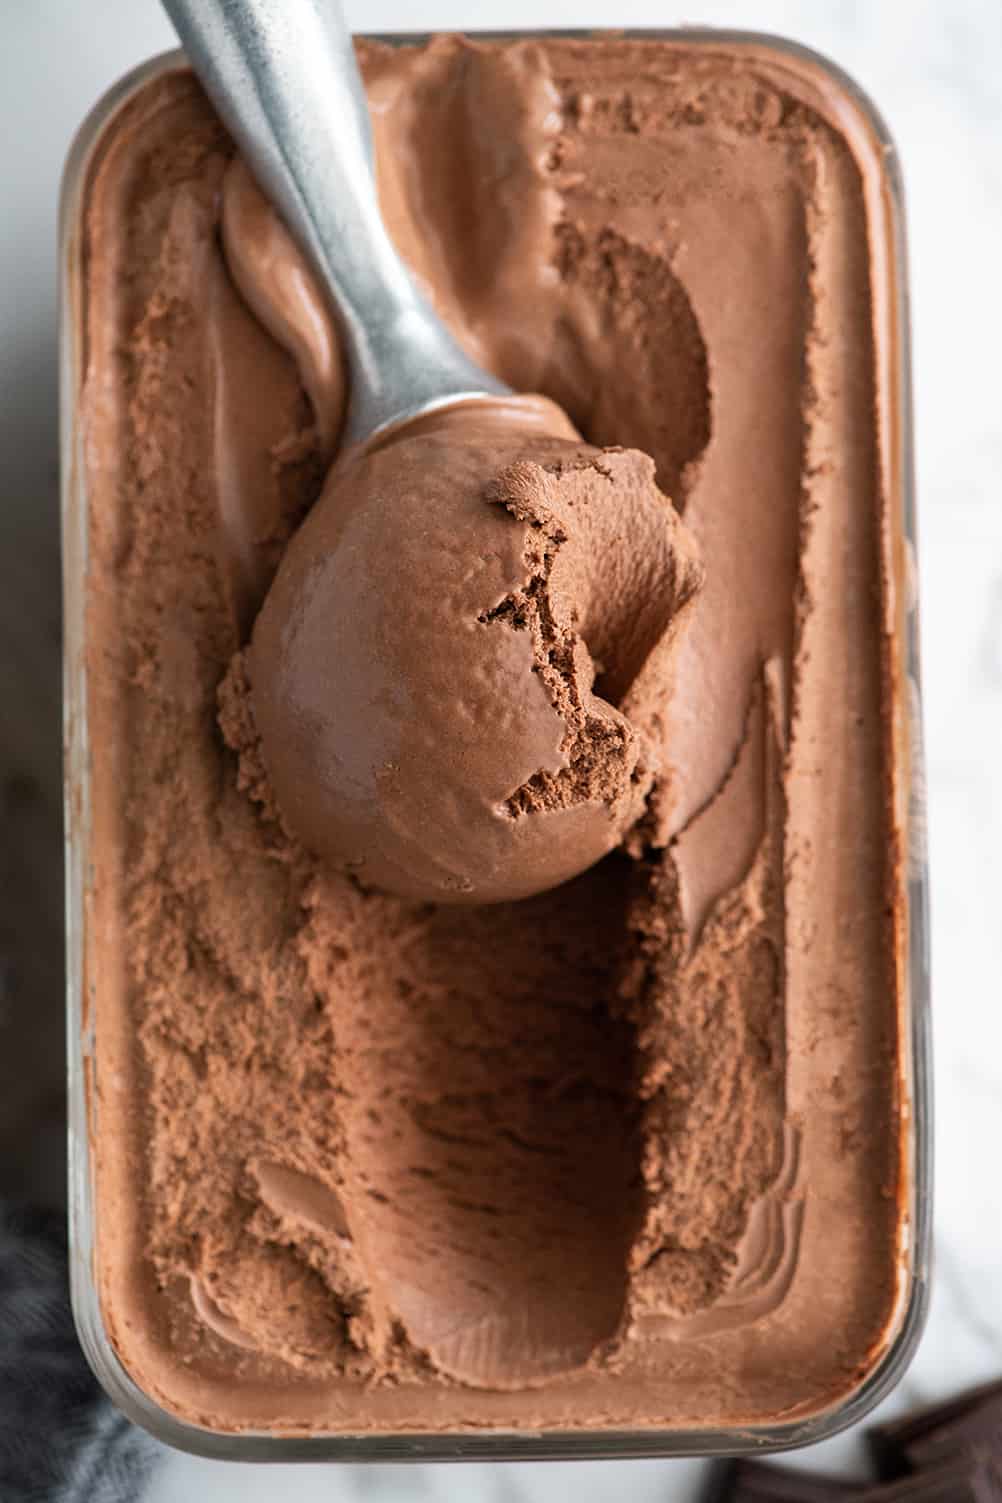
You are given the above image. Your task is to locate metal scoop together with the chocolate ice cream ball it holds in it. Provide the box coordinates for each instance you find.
[165,0,700,902]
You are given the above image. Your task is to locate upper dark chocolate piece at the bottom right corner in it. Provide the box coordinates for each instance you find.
[868,1381,1002,1477]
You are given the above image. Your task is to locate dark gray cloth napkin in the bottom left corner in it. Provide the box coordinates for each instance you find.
[0,1199,162,1503]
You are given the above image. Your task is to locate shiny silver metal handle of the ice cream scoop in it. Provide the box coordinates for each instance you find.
[164,0,511,445]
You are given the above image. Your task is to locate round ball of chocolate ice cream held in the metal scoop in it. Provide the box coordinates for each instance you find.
[246,398,702,903]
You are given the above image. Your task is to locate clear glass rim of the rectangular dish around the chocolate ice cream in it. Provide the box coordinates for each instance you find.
[62,29,931,1461]
